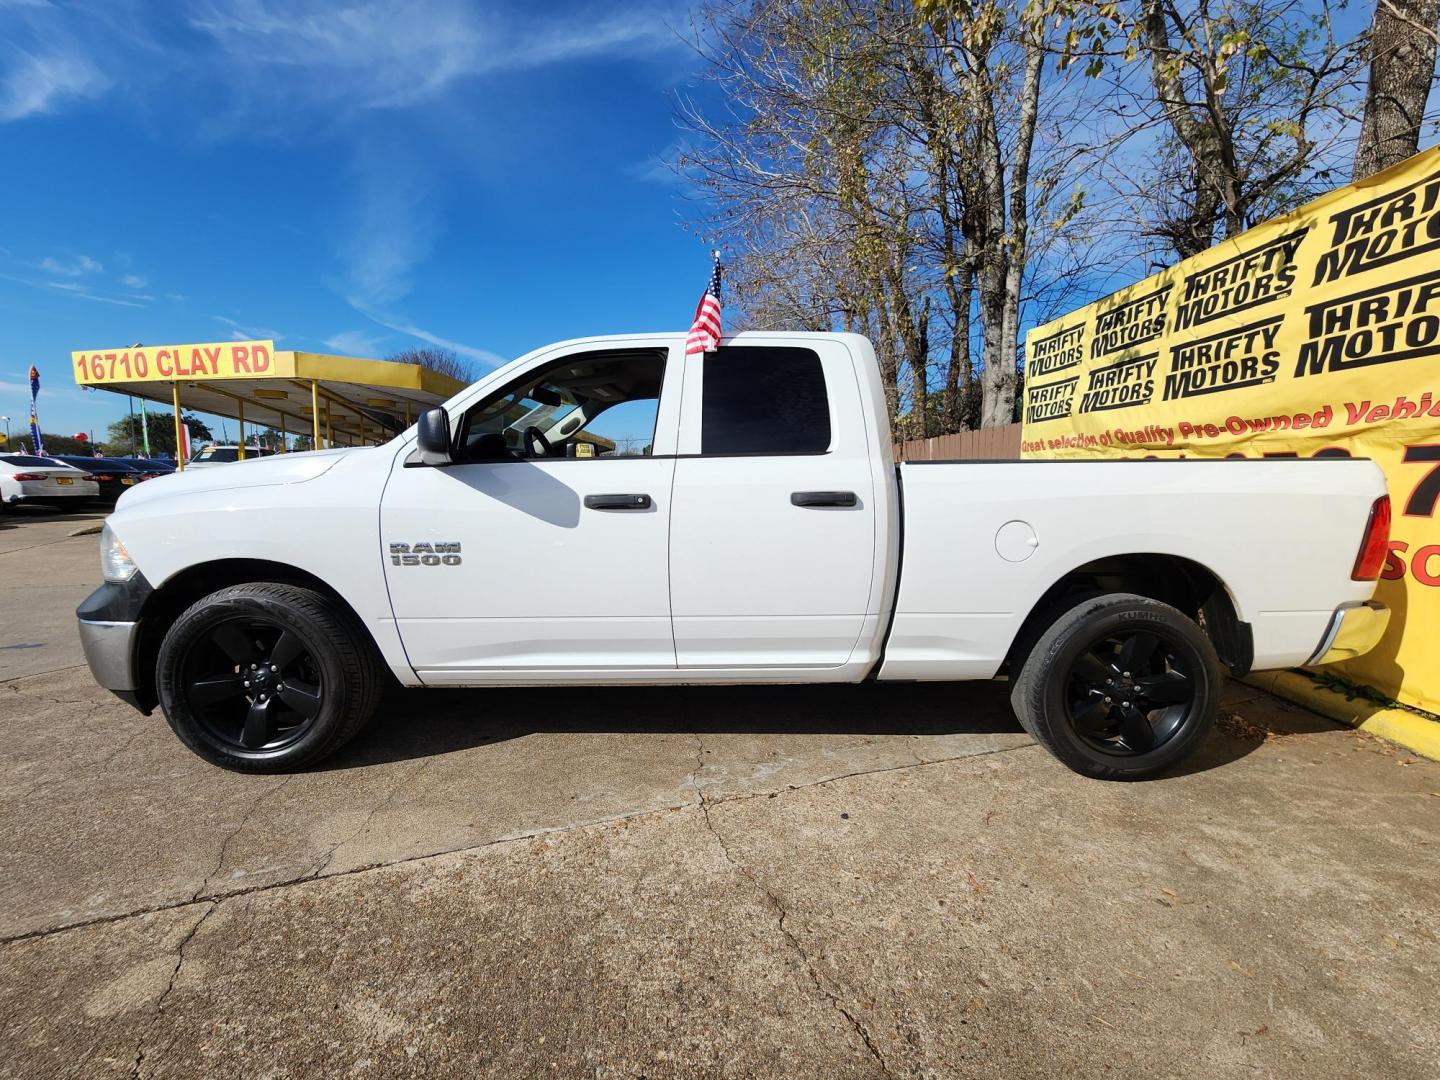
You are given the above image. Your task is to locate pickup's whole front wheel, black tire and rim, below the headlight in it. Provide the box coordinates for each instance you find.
[156,582,383,773]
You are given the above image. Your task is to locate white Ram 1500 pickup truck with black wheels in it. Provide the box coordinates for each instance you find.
[78,333,1390,779]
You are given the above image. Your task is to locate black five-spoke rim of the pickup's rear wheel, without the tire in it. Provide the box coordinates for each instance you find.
[1067,629,1197,756]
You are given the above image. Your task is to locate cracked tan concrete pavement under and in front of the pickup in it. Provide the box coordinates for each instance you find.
[0,512,1440,1077]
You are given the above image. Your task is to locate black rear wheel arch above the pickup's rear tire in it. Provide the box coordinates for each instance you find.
[1001,552,1254,677]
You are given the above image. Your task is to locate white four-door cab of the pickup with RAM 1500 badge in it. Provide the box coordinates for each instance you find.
[380,336,897,684]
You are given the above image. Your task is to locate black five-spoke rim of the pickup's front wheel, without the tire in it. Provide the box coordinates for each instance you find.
[183,616,325,750]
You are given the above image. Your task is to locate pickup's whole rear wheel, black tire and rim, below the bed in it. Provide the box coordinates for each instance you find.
[1009,593,1220,780]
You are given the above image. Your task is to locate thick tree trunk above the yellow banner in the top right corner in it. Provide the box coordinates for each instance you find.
[1354,0,1440,180]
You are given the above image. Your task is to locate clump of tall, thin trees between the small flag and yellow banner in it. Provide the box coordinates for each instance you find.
[680,0,1082,438]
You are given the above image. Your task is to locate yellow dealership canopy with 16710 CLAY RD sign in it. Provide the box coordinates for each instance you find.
[71,341,465,466]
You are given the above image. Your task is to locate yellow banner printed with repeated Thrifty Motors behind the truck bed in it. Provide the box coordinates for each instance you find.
[1022,150,1440,711]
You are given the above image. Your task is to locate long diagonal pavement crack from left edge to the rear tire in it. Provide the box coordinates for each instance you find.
[0,736,1037,946]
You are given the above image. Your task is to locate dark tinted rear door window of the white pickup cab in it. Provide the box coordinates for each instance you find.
[700,346,831,455]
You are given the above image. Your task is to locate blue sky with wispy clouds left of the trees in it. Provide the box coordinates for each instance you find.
[0,0,708,438]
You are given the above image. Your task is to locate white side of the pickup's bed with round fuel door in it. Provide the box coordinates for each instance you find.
[881,458,1384,680]
